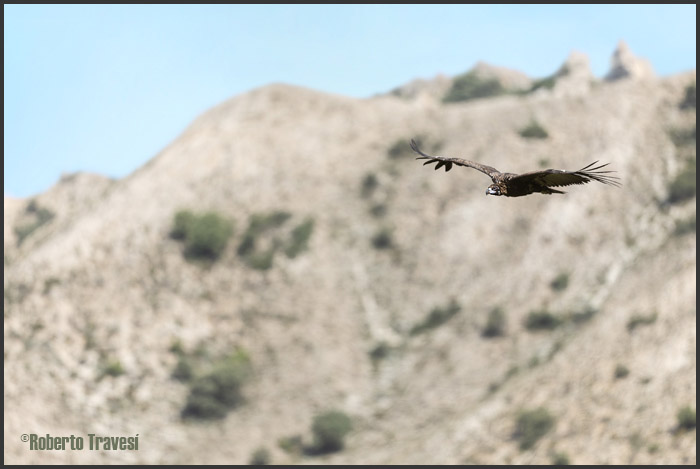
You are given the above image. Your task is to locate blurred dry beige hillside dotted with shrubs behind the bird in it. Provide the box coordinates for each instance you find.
[4,47,696,464]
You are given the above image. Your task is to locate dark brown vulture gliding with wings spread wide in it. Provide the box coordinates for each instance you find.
[411,140,621,197]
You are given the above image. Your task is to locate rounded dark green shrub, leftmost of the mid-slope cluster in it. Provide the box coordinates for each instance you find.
[170,210,233,261]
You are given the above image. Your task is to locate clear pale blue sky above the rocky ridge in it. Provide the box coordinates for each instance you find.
[4,4,696,197]
